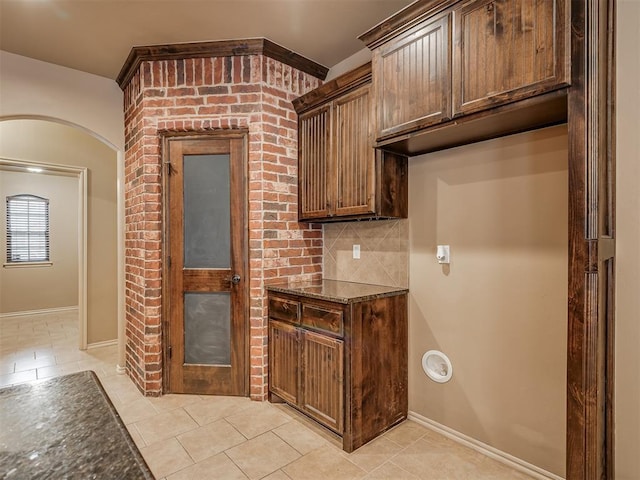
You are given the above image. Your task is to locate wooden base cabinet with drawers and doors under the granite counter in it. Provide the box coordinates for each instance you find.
[268,286,408,452]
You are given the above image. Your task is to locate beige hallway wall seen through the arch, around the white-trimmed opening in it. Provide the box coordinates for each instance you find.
[0,120,118,344]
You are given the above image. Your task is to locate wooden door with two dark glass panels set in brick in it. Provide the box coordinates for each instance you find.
[164,134,248,395]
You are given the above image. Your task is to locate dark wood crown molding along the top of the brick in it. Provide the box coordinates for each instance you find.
[116,38,329,90]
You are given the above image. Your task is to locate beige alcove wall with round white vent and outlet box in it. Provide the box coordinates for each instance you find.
[409,126,568,475]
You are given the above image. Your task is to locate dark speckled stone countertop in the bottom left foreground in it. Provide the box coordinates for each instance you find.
[0,371,154,480]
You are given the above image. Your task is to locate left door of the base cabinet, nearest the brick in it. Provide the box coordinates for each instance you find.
[269,320,300,405]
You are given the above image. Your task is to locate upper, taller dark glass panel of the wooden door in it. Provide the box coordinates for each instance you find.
[184,154,231,268]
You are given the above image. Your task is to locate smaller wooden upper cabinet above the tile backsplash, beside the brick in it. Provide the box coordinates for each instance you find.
[293,63,407,222]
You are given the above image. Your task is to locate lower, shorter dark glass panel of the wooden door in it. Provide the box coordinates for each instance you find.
[184,293,231,365]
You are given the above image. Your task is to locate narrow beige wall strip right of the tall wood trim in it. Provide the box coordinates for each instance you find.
[615,0,640,480]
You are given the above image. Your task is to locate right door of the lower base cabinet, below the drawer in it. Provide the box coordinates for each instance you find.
[300,330,344,434]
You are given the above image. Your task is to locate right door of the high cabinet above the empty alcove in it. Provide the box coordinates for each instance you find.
[453,0,569,115]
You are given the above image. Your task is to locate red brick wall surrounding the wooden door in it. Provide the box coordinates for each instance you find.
[124,55,322,400]
